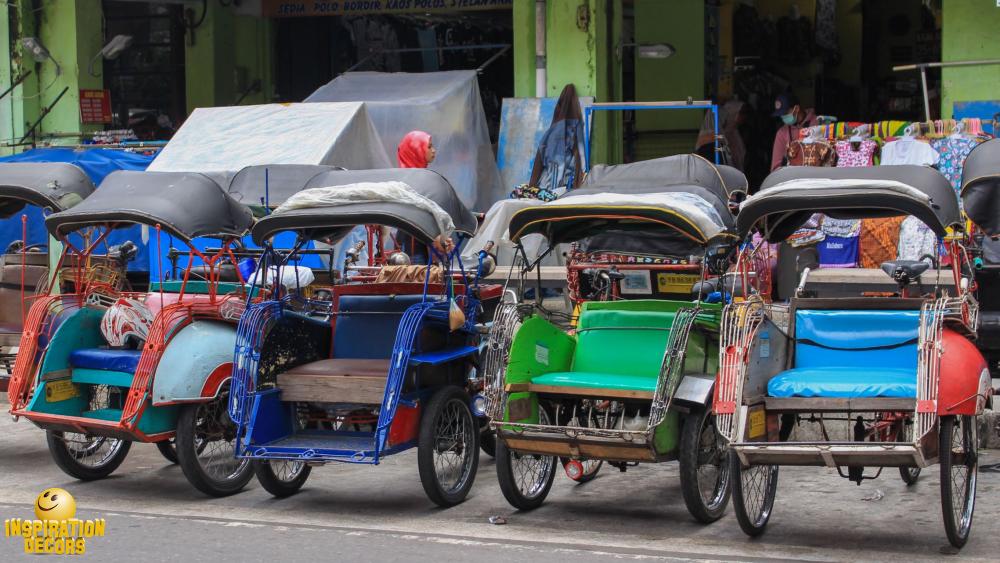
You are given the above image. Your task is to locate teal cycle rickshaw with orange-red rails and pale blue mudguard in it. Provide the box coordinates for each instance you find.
[8,171,262,496]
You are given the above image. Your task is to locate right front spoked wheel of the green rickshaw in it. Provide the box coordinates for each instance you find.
[680,408,731,524]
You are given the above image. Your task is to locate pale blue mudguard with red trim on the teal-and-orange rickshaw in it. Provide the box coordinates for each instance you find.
[152,321,236,406]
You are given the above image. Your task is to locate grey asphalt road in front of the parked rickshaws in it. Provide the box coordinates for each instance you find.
[0,396,1000,563]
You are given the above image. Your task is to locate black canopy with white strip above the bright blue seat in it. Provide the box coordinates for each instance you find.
[736,165,962,242]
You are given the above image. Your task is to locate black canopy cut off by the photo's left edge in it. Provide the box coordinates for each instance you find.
[0,162,94,219]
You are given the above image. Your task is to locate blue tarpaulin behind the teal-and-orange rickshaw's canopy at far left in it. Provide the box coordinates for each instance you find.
[0,148,153,271]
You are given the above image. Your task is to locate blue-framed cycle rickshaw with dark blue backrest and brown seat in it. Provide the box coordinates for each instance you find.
[230,169,500,506]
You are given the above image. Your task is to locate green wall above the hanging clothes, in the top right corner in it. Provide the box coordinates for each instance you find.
[941,0,1000,119]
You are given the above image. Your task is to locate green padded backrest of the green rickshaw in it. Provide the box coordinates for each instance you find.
[573,308,676,377]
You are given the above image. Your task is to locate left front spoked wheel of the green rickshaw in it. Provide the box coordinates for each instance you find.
[497,405,556,510]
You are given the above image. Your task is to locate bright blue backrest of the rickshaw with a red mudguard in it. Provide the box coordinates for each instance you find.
[795,309,920,370]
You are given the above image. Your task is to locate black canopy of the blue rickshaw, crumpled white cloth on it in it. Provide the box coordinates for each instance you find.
[251,168,478,244]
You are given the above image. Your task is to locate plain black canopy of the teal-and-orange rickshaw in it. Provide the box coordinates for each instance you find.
[45,170,253,243]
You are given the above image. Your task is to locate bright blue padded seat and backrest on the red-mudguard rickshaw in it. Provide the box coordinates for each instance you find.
[767,310,920,398]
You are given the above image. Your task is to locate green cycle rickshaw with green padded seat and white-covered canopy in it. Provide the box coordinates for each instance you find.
[483,155,735,523]
